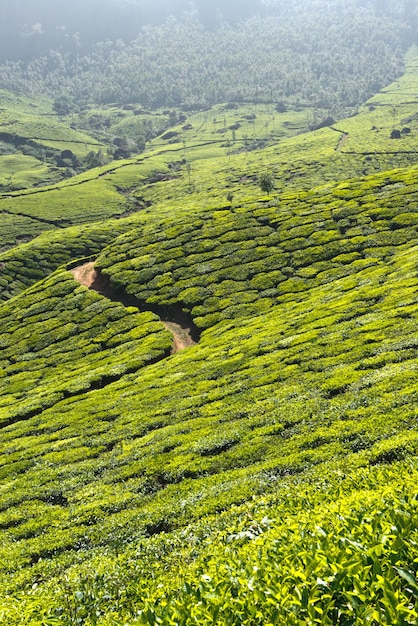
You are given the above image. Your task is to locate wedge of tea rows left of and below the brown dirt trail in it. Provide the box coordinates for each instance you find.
[0,271,172,426]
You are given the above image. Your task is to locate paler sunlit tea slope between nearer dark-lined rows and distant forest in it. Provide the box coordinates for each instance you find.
[0,52,417,256]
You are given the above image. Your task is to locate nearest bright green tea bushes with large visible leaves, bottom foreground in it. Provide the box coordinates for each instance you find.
[36,463,418,626]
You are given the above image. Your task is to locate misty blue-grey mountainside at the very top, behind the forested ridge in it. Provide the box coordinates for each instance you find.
[0,0,417,62]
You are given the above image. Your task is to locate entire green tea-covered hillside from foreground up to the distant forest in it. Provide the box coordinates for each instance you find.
[0,49,418,626]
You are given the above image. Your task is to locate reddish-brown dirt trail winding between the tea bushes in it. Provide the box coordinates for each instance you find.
[70,261,197,354]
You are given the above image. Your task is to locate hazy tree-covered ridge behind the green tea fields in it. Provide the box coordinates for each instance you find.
[0,1,415,115]
